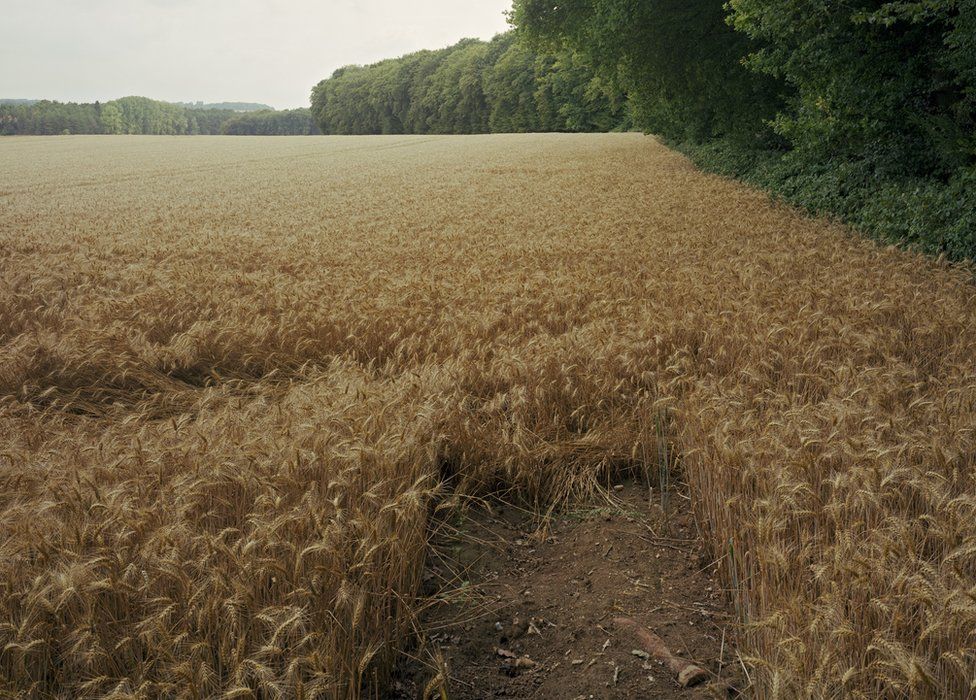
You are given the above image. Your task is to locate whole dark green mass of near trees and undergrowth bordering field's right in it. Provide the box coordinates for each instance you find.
[513,0,976,259]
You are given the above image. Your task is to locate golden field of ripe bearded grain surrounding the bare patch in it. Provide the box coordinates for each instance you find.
[0,134,976,699]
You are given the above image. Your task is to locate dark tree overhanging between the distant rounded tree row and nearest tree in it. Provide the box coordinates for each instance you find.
[513,0,779,140]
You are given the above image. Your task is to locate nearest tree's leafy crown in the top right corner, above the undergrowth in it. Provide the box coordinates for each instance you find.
[730,0,976,176]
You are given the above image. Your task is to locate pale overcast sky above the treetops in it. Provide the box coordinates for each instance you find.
[0,0,511,109]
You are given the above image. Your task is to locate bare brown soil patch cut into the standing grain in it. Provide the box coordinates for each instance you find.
[394,483,747,700]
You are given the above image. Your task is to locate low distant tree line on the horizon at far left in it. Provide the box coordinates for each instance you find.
[0,97,317,135]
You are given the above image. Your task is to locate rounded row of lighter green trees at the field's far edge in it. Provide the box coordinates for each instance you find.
[312,32,630,134]
